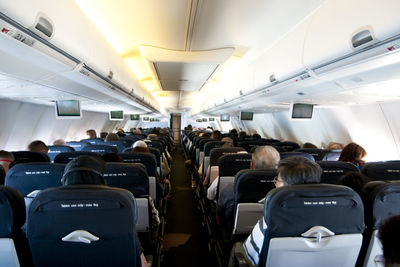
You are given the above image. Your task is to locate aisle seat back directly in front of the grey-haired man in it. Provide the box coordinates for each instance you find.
[216,153,251,202]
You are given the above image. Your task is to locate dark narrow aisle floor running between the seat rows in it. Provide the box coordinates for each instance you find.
[161,146,216,267]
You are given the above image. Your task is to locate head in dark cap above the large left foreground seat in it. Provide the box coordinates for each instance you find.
[61,156,106,185]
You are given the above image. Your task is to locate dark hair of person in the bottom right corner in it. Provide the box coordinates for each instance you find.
[378,215,400,266]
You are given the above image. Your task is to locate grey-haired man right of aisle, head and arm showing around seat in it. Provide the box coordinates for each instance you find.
[214,146,280,230]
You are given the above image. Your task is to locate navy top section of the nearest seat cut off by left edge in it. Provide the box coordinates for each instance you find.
[0,186,26,237]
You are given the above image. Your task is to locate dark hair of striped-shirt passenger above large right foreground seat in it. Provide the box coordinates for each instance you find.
[278,156,322,185]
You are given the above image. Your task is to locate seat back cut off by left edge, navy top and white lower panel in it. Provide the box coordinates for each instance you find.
[0,186,31,267]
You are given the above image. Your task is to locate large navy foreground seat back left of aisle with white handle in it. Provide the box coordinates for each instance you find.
[27,185,140,266]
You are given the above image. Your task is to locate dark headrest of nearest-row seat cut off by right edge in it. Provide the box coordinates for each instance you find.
[361,181,400,230]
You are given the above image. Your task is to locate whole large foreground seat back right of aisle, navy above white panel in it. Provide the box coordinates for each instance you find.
[260,184,364,267]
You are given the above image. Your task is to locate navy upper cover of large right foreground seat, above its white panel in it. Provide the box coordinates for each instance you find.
[264,184,365,238]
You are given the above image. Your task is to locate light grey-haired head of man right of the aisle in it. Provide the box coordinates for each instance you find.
[251,146,280,169]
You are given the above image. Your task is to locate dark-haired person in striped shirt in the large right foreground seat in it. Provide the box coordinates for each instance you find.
[233,157,322,266]
